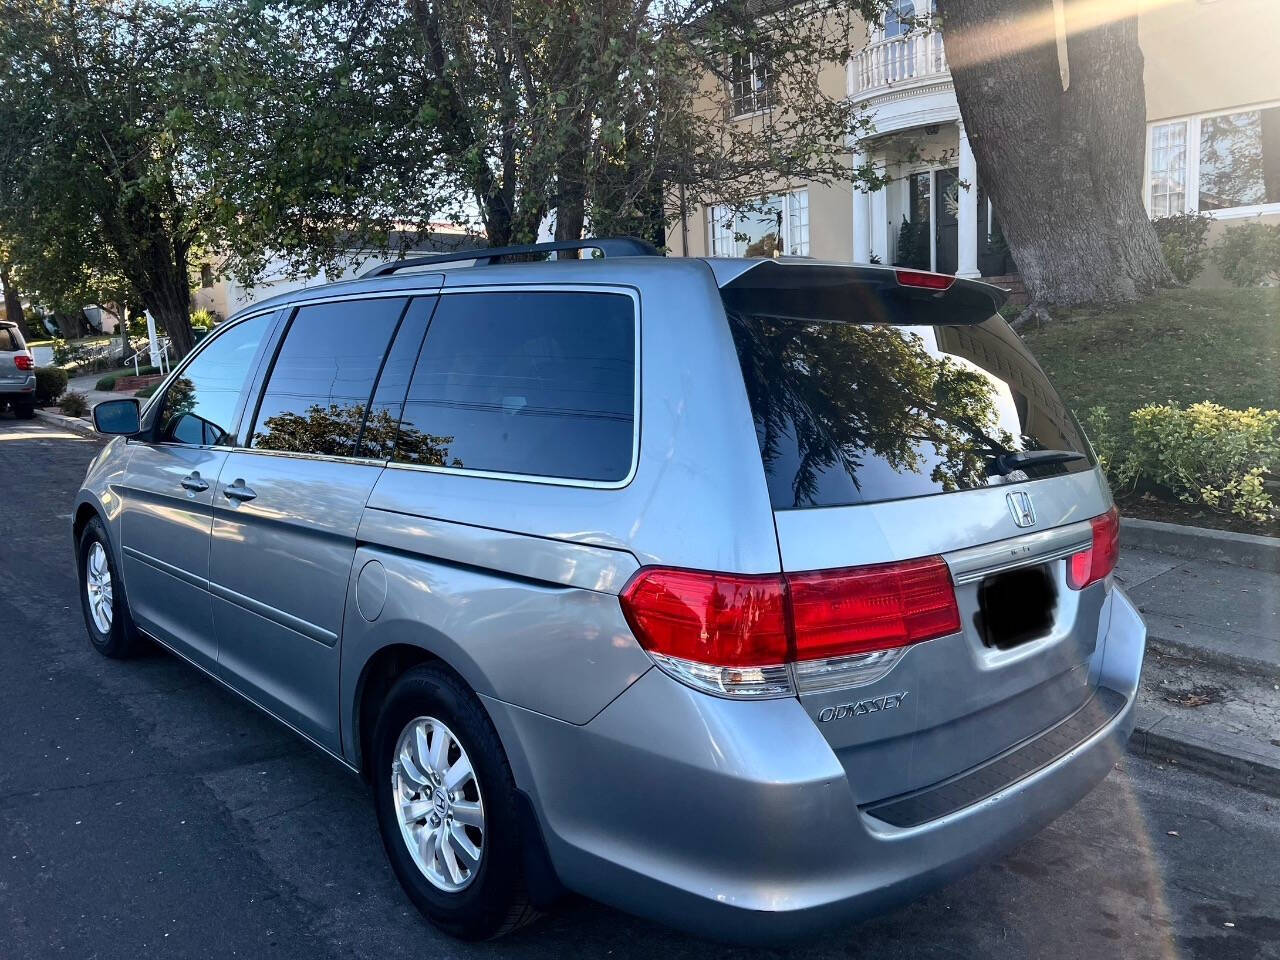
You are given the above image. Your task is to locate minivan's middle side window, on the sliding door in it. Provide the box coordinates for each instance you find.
[250,298,406,457]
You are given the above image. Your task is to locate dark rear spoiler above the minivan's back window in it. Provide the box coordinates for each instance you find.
[708,260,1009,326]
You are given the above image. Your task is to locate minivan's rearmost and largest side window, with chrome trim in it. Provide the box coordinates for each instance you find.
[396,292,636,481]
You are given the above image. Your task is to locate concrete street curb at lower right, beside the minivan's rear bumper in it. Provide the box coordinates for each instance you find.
[1129,710,1280,796]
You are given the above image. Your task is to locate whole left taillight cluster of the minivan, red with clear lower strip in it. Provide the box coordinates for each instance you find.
[620,557,960,696]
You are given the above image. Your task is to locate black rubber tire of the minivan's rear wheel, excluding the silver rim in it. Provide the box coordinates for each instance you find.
[371,664,538,941]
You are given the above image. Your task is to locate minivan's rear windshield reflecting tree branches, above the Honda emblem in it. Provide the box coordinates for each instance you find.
[724,302,1093,509]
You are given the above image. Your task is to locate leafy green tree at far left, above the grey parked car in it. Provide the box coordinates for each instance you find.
[0,0,253,356]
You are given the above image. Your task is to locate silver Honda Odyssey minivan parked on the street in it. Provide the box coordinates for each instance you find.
[73,239,1146,942]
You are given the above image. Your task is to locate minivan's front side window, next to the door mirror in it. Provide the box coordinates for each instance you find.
[157,314,273,445]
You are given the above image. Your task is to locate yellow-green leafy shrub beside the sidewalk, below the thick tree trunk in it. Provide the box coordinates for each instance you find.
[1130,403,1280,522]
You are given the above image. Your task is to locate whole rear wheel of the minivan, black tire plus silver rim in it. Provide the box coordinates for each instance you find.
[371,664,538,940]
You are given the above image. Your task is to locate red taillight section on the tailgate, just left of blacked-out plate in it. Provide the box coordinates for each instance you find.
[787,557,960,660]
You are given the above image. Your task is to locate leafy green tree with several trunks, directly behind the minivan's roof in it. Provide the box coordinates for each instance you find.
[220,0,882,261]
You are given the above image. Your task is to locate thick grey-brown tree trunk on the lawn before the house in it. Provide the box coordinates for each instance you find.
[938,0,1172,307]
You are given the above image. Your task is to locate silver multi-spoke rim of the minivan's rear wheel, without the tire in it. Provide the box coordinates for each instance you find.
[392,717,485,893]
